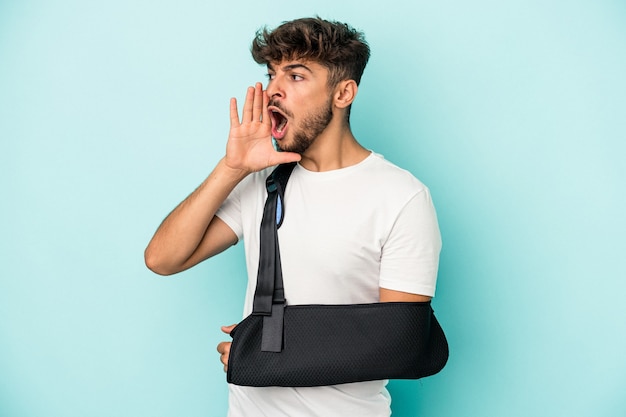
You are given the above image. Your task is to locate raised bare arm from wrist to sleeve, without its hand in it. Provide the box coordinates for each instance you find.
[144,159,247,275]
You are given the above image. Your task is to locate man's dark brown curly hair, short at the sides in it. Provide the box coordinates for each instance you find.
[251,17,370,88]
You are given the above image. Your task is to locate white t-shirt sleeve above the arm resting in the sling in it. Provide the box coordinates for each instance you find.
[380,188,441,297]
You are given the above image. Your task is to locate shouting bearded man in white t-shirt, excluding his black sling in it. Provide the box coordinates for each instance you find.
[145,18,441,417]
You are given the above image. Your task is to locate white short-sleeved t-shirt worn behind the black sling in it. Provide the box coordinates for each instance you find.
[217,153,441,417]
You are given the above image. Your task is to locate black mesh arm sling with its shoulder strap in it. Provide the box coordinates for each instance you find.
[227,163,448,387]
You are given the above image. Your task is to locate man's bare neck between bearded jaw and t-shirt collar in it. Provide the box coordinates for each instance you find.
[300,117,370,172]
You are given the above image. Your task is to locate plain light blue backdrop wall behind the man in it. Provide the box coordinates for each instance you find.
[0,0,626,417]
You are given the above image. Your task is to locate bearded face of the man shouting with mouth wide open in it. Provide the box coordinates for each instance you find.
[267,61,333,154]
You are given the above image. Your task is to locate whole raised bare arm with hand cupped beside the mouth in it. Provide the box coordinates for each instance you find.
[144,83,300,275]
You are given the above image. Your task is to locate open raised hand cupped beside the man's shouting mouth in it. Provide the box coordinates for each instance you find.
[225,83,301,172]
